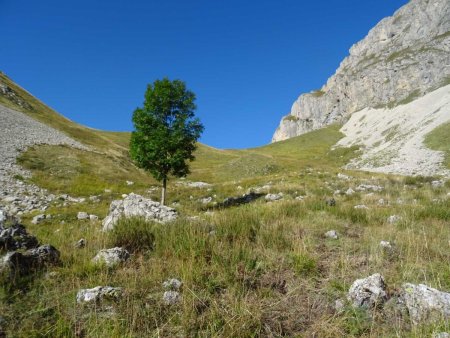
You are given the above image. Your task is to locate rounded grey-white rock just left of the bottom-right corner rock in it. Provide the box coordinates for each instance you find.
[347,273,387,308]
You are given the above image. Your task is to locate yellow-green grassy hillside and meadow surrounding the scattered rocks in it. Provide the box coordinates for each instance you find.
[0,72,450,337]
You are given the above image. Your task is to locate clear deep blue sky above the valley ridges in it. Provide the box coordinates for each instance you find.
[0,0,407,148]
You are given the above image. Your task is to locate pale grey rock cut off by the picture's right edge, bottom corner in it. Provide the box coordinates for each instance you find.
[400,283,450,324]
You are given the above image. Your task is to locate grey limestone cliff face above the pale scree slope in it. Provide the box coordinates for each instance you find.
[272,0,450,142]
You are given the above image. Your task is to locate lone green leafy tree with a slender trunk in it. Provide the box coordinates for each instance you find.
[130,78,204,205]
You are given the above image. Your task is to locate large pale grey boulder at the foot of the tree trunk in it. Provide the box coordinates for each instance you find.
[103,193,177,231]
